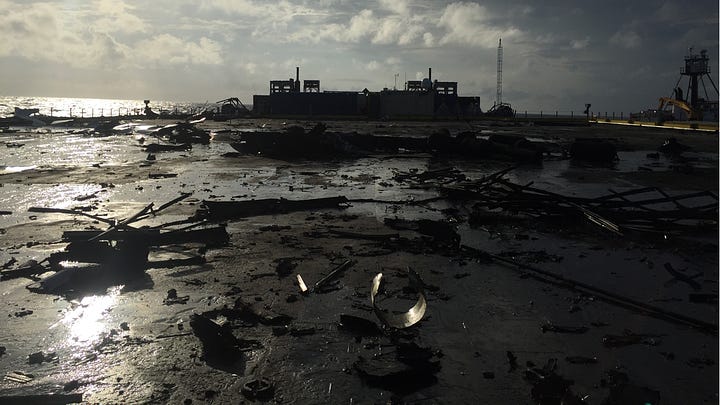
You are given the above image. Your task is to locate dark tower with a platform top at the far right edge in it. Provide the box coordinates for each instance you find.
[658,48,718,121]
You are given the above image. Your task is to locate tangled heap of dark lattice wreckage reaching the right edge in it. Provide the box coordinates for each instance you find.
[441,166,718,238]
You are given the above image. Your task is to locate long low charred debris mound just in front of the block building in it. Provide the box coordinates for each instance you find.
[230,122,617,164]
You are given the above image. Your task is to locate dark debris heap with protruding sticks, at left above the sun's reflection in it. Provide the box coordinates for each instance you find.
[1,194,229,293]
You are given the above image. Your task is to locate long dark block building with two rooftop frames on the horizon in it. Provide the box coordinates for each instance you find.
[253,67,482,119]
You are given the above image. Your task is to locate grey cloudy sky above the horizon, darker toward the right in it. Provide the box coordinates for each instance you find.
[0,0,720,112]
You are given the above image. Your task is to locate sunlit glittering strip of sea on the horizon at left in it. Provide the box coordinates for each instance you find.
[0,96,210,117]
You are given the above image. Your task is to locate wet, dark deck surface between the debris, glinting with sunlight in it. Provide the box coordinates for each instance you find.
[0,121,719,404]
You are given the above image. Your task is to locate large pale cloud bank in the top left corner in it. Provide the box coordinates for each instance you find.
[0,0,223,68]
